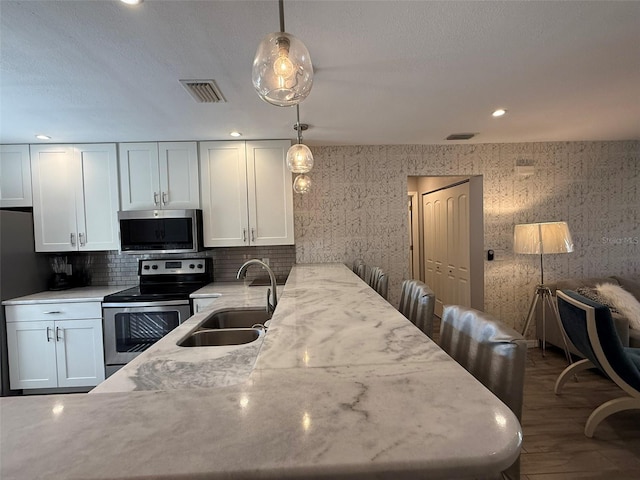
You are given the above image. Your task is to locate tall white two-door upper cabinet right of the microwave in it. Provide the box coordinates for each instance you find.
[200,140,294,247]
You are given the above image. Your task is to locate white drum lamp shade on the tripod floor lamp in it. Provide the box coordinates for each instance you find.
[513,222,573,255]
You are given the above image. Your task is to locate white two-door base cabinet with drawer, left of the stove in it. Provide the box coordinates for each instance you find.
[5,302,104,389]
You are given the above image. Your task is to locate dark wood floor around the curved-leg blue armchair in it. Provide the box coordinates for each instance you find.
[520,348,640,480]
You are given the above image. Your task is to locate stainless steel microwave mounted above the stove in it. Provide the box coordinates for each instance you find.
[118,209,202,254]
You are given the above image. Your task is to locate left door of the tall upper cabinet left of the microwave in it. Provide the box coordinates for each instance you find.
[31,145,78,252]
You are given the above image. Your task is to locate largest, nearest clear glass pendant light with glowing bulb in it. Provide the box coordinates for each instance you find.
[251,0,313,107]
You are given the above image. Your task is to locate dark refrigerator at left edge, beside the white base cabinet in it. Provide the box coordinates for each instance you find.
[0,210,51,396]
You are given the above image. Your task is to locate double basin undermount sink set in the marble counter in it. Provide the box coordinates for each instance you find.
[178,308,271,347]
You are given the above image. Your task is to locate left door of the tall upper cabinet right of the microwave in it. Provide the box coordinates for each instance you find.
[200,142,249,247]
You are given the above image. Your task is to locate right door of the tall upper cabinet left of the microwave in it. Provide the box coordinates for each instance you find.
[75,144,120,251]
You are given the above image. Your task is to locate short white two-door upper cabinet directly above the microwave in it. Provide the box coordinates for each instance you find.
[120,142,200,210]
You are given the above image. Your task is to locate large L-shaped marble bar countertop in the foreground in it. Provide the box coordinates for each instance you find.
[0,265,522,479]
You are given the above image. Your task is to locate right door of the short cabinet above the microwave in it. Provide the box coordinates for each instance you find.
[158,142,200,210]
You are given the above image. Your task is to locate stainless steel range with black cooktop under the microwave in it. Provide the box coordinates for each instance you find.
[102,257,213,376]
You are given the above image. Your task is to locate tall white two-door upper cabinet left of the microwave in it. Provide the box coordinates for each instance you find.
[31,144,119,252]
